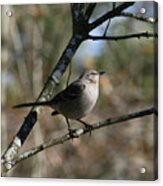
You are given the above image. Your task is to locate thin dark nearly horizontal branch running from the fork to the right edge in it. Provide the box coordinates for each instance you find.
[88,32,158,41]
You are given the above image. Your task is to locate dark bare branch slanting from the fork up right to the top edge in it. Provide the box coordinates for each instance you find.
[89,2,134,30]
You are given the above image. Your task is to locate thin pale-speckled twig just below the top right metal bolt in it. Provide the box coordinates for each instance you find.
[117,12,158,24]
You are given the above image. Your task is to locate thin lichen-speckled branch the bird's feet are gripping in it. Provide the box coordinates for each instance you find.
[2,107,157,173]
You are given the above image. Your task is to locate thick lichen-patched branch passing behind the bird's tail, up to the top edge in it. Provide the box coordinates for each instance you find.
[1,4,88,172]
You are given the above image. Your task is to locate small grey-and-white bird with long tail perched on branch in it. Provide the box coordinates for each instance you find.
[13,70,104,132]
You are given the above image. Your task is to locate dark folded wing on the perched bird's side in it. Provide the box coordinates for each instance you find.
[54,81,85,102]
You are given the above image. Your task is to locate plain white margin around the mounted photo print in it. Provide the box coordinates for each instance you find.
[0,0,163,186]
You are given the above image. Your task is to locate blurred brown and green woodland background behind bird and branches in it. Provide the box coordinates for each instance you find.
[1,2,155,180]
